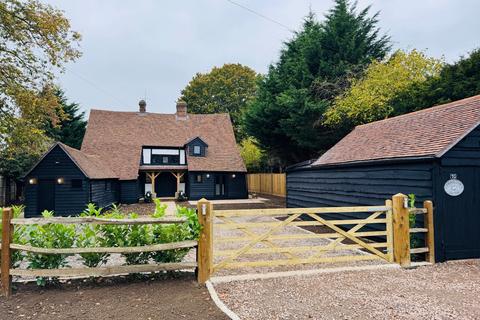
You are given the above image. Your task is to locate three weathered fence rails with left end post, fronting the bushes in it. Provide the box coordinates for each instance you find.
[0,208,198,297]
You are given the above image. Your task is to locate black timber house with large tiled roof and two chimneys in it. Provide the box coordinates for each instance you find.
[25,100,248,216]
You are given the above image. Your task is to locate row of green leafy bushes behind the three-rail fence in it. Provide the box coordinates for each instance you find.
[0,199,201,286]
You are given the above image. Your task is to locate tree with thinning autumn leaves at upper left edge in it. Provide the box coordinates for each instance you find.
[0,0,80,177]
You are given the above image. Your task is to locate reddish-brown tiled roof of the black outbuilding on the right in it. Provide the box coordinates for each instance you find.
[313,95,480,166]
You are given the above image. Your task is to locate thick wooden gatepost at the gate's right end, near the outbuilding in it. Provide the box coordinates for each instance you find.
[392,193,410,268]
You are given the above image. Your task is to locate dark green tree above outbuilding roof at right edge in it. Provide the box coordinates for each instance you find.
[390,49,480,114]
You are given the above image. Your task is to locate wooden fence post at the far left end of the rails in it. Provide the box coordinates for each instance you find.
[1,208,13,298]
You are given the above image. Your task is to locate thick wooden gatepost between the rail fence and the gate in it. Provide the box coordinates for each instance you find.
[197,198,213,284]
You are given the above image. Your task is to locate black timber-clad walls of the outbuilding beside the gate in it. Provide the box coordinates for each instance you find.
[287,127,480,261]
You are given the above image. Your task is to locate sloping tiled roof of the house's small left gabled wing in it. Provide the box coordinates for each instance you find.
[57,142,118,179]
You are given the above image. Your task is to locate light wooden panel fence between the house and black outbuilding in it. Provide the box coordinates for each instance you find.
[247,173,287,197]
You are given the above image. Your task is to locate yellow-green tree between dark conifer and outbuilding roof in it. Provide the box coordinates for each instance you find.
[325,50,442,130]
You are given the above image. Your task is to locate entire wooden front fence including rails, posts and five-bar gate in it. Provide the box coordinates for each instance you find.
[0,194,435,297]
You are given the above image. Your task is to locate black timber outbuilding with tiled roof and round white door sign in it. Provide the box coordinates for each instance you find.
[287,95,480,261]
